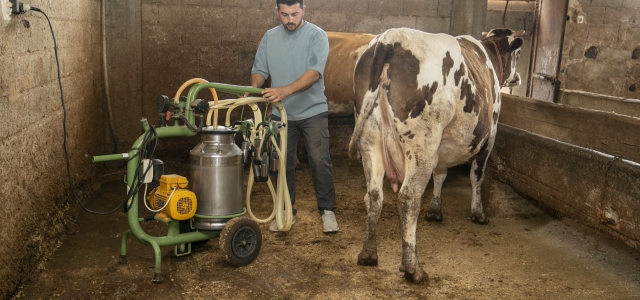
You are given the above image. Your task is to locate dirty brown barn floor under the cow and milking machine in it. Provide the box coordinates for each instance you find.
[14,159,640,299]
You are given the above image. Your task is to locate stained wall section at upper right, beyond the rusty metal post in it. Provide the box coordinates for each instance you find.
[559,0,640,99]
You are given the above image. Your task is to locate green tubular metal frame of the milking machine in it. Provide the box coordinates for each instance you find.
[93,83,263,282]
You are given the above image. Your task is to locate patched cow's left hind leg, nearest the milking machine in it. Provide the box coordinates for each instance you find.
[358,146,384,266]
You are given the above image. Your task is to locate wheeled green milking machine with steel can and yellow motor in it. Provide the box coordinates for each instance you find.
[93,78,293,282]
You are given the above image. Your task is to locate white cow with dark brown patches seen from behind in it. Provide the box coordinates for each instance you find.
[349,28,524,283]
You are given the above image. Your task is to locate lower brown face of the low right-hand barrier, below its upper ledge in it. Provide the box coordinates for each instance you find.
[482,124,640,249]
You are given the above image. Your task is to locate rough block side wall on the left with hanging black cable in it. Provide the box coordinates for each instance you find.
[0,0,105,299]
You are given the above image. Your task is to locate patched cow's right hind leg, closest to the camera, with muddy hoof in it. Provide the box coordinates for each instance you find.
[398,169,430,283]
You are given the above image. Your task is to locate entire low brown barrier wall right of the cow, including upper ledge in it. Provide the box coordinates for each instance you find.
[483,94,640,249]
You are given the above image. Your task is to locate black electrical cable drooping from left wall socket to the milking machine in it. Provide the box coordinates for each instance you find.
[30,7,158,215]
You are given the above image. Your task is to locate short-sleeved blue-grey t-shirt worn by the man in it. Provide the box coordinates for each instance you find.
[251,21,329,121]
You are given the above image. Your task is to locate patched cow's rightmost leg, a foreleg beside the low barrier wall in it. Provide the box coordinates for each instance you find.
[469,139,493,225]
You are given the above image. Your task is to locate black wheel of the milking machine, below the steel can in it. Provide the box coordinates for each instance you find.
[220,217,262,267]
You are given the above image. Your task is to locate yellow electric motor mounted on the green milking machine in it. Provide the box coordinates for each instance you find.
[147,174,198,221]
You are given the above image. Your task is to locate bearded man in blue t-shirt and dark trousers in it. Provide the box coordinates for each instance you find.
[251,0,339,233]
